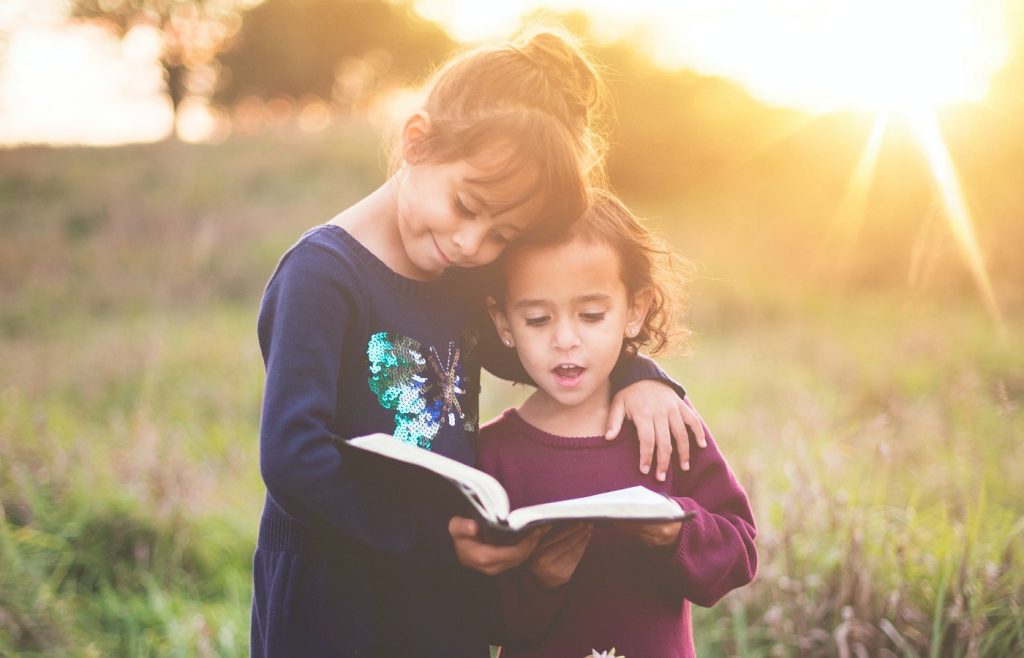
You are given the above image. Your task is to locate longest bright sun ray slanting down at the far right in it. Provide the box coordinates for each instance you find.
[906,109,1002,326]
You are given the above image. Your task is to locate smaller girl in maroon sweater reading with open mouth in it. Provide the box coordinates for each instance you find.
[479,192,757,658]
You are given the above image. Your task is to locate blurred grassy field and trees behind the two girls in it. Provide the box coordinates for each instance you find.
[0,0,1024,658]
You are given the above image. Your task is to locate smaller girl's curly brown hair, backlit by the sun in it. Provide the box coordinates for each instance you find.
[499,188,696,354]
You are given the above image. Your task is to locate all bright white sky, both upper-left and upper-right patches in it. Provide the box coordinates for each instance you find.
[0,0,1011,143]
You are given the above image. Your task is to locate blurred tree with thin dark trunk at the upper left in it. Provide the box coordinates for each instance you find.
[72,0,247,122]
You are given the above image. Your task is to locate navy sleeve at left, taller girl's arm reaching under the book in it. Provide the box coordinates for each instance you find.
[258,244,455,563]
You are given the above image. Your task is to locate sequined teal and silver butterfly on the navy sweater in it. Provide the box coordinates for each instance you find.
[367,332,479,450]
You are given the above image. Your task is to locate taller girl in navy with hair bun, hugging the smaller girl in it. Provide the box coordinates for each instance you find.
[252,32,699,658]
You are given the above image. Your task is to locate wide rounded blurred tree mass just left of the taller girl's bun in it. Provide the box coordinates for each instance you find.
[215,0,454,108]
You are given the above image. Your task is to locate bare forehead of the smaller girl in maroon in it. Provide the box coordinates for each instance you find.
[505,238,626,303]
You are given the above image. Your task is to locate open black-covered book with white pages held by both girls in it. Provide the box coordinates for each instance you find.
[336,434,692,544]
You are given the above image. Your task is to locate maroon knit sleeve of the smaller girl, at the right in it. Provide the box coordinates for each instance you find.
[649,407,758,607]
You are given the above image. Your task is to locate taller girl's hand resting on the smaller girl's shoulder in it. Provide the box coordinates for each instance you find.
[604,380,708,482]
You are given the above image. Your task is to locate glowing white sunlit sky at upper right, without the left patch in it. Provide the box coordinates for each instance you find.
[416,0,1009,112]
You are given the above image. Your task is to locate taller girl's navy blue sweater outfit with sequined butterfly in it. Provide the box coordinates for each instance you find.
[252,225,682,658]
